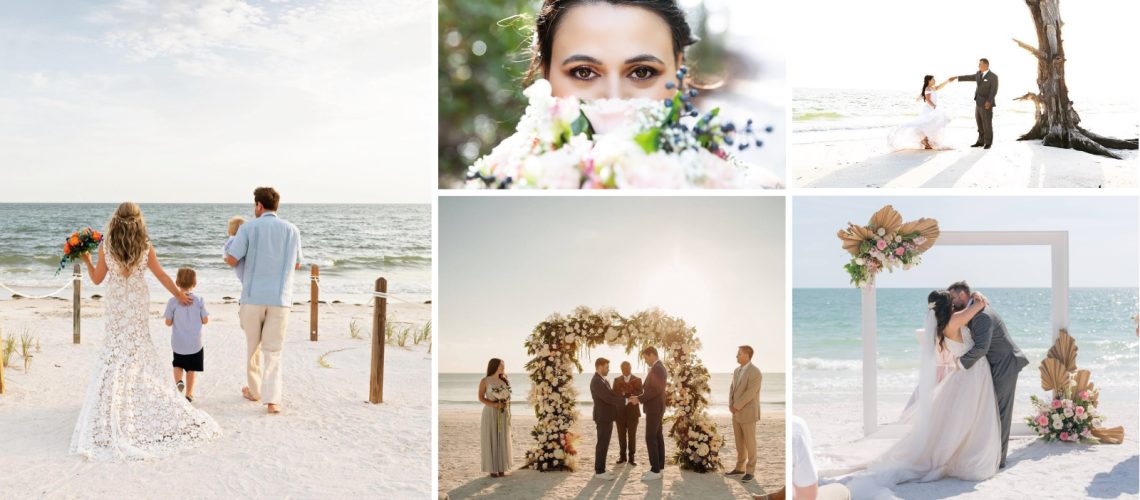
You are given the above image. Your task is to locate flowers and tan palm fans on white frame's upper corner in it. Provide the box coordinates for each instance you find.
[838,205,939,288]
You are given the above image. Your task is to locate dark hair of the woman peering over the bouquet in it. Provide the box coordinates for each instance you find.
[526,0,697,82]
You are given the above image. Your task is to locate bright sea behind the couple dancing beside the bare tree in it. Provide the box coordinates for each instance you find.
[792,84,1138,138]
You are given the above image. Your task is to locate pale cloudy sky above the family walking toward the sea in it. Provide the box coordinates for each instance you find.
[0,0,437,203]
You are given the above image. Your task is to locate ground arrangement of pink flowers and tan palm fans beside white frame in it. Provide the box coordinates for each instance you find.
[1025,329,1124,444]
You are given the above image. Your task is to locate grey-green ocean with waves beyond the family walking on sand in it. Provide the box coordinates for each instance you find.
[0,204,432,303]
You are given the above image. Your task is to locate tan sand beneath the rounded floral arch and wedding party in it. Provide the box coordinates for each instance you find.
[439,404,784,499]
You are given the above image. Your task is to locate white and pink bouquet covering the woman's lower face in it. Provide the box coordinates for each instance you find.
[467,66,781,189]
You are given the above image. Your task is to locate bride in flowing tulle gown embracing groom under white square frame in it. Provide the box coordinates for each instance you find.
[848,290,1001,498]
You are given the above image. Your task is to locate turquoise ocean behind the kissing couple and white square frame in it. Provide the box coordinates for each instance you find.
[792,288,1140,404]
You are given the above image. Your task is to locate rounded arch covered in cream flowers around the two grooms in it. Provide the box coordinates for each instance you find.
[526,306,724,473]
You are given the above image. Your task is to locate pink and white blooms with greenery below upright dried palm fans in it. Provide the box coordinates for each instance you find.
[1025,390,1102,444]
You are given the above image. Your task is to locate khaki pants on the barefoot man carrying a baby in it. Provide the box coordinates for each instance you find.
[237,304,290,404]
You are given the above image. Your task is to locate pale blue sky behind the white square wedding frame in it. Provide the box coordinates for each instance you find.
[792,196,1140,288]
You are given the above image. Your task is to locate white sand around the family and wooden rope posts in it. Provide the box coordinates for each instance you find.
[0,300,432,498]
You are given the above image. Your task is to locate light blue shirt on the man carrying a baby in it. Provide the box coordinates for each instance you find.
[228,212,301,308]
